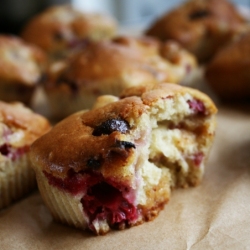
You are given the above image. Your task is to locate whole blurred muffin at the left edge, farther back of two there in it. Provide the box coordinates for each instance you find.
[0,35,46,105]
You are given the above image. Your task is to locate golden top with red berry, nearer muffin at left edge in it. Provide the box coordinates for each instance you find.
[0,101,50,151]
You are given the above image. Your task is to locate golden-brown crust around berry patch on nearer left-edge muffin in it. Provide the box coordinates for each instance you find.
[0,101,50,147]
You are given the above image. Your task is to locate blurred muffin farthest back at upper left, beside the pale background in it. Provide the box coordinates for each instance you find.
[22,5,116,59]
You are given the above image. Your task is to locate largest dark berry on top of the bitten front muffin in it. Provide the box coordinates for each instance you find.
[92,119,130,136]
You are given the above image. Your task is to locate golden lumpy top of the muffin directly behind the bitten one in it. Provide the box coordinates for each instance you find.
[44,37,196,94]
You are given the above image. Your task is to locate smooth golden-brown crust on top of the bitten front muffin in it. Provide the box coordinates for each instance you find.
[31,97,145,179]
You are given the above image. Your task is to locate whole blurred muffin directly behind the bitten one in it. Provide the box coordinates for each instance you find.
[45,37,196,119]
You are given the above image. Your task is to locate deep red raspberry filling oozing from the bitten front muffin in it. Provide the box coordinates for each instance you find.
[44,171,138,231]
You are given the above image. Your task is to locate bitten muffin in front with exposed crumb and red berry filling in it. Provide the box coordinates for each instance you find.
[31,84,216,234]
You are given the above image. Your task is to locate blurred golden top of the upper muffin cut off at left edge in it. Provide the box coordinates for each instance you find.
[0,35,46,86]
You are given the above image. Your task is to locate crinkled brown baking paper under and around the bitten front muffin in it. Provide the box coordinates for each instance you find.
[0,102,250,250]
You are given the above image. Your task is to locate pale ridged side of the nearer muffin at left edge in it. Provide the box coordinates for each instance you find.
[0,154,36,209]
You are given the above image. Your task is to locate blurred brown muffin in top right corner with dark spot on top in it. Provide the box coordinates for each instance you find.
[145,0,246,63]
